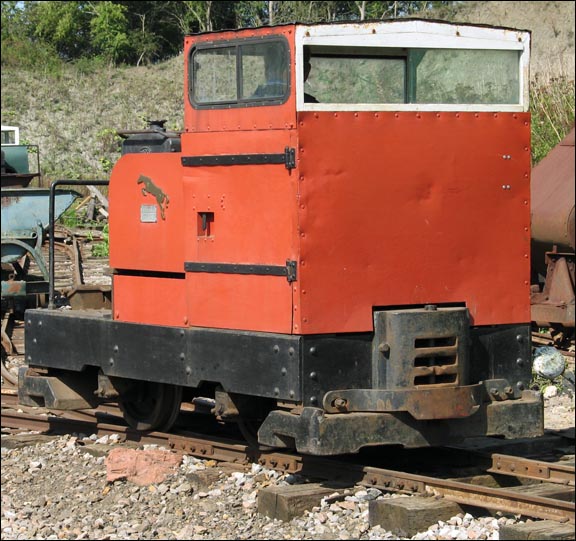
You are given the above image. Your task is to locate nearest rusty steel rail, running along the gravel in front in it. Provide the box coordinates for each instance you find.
[2,404,575,523]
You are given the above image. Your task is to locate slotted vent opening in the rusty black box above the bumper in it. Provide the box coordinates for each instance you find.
[412,336,459,386]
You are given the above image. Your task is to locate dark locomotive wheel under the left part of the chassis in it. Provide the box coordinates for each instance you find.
[120,381,182,432]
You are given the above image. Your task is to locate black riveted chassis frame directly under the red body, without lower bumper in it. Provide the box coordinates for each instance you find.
[25,309,531,406]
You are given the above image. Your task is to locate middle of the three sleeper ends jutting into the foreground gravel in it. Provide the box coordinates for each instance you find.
[368,496,462,537]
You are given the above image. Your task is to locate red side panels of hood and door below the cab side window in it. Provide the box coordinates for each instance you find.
[110,130,297,333]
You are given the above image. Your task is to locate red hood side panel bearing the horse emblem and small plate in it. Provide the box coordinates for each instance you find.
[109,154,187,326]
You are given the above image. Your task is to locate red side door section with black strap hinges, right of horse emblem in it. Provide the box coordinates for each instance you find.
[183,130,297,333]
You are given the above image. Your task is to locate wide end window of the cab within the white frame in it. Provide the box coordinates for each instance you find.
[304,46,521,105]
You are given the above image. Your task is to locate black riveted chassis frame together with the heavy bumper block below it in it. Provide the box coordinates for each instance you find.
[19,309,543,454]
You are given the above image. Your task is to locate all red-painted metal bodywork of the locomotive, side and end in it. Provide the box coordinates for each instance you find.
[110,25,530,334]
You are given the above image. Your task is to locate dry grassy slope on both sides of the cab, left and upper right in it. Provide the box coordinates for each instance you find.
[2,2,574,180]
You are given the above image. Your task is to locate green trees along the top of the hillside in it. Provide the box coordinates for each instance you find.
[1,0,459,66]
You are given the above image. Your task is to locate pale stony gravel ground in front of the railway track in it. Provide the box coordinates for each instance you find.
[1,393,574,540]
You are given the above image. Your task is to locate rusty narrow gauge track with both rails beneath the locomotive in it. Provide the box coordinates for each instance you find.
[2,391,575,523]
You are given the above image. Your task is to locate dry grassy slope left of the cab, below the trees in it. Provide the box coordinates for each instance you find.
[2,56,184,180]
